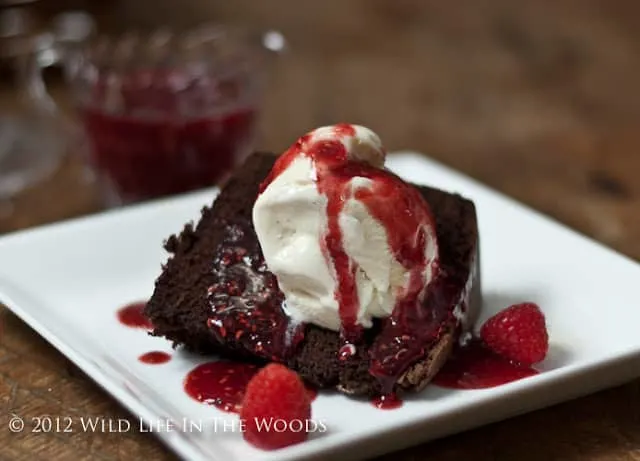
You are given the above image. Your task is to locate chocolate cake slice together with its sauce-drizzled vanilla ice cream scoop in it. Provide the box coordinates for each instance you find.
[145,125,481,396]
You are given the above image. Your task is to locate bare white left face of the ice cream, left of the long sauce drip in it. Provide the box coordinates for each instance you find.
[253,156,340,330]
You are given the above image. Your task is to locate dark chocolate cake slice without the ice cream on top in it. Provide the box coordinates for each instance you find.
[145,153,480,396]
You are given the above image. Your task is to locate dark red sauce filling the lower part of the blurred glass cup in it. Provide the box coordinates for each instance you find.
[83,109,255,202]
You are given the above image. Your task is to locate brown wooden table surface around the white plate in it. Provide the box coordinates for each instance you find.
[0,0,640,461]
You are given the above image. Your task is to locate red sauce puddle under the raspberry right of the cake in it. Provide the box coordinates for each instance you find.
[433,339,538,389]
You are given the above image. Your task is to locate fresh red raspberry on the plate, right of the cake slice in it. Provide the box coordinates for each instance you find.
[480,303,549,365]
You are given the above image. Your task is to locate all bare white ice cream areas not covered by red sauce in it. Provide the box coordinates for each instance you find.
[253,125,434,331]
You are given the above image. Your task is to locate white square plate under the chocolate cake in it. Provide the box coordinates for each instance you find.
[0,153,640,461]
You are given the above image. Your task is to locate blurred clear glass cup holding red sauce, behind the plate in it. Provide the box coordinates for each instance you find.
[66,27,278,206]
